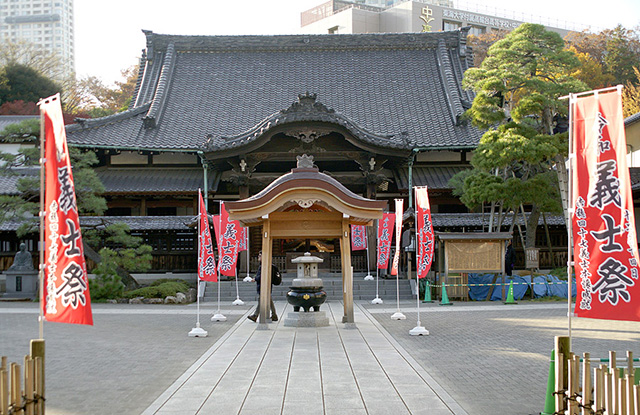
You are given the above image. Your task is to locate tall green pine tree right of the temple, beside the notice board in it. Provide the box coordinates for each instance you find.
[452,23,587,247]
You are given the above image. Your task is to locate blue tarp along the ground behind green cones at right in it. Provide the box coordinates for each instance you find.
[469,274,576,301]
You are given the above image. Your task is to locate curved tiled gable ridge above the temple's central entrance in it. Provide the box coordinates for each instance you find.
[205,92,410,150]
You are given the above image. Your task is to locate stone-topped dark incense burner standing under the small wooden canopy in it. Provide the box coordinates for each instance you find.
[284,252,329,327]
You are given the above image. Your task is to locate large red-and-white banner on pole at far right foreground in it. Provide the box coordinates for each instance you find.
[572,91,640,321]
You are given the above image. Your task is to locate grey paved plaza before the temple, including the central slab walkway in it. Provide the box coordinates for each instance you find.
[0,300,640,415]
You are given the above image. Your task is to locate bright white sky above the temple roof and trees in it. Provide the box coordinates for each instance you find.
[75,0,640,84]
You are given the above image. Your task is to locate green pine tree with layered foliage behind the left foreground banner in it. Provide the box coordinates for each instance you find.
[0,120,146,292]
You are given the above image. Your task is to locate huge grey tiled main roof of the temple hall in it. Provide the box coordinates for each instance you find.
[67,31,480,151]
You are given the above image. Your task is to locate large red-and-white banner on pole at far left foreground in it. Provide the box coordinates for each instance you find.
[40,94,93,325]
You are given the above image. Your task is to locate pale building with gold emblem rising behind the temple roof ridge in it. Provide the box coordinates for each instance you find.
[300,0,582,37]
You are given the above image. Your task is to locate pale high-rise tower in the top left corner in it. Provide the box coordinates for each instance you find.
[0,0,75,77]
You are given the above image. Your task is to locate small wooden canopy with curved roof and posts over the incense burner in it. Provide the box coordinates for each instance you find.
[226,155,387,330]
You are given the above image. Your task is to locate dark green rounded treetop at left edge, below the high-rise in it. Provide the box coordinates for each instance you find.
[0,63,61,105]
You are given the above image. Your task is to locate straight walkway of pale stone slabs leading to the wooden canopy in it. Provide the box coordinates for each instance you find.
[144,303,465,415]
